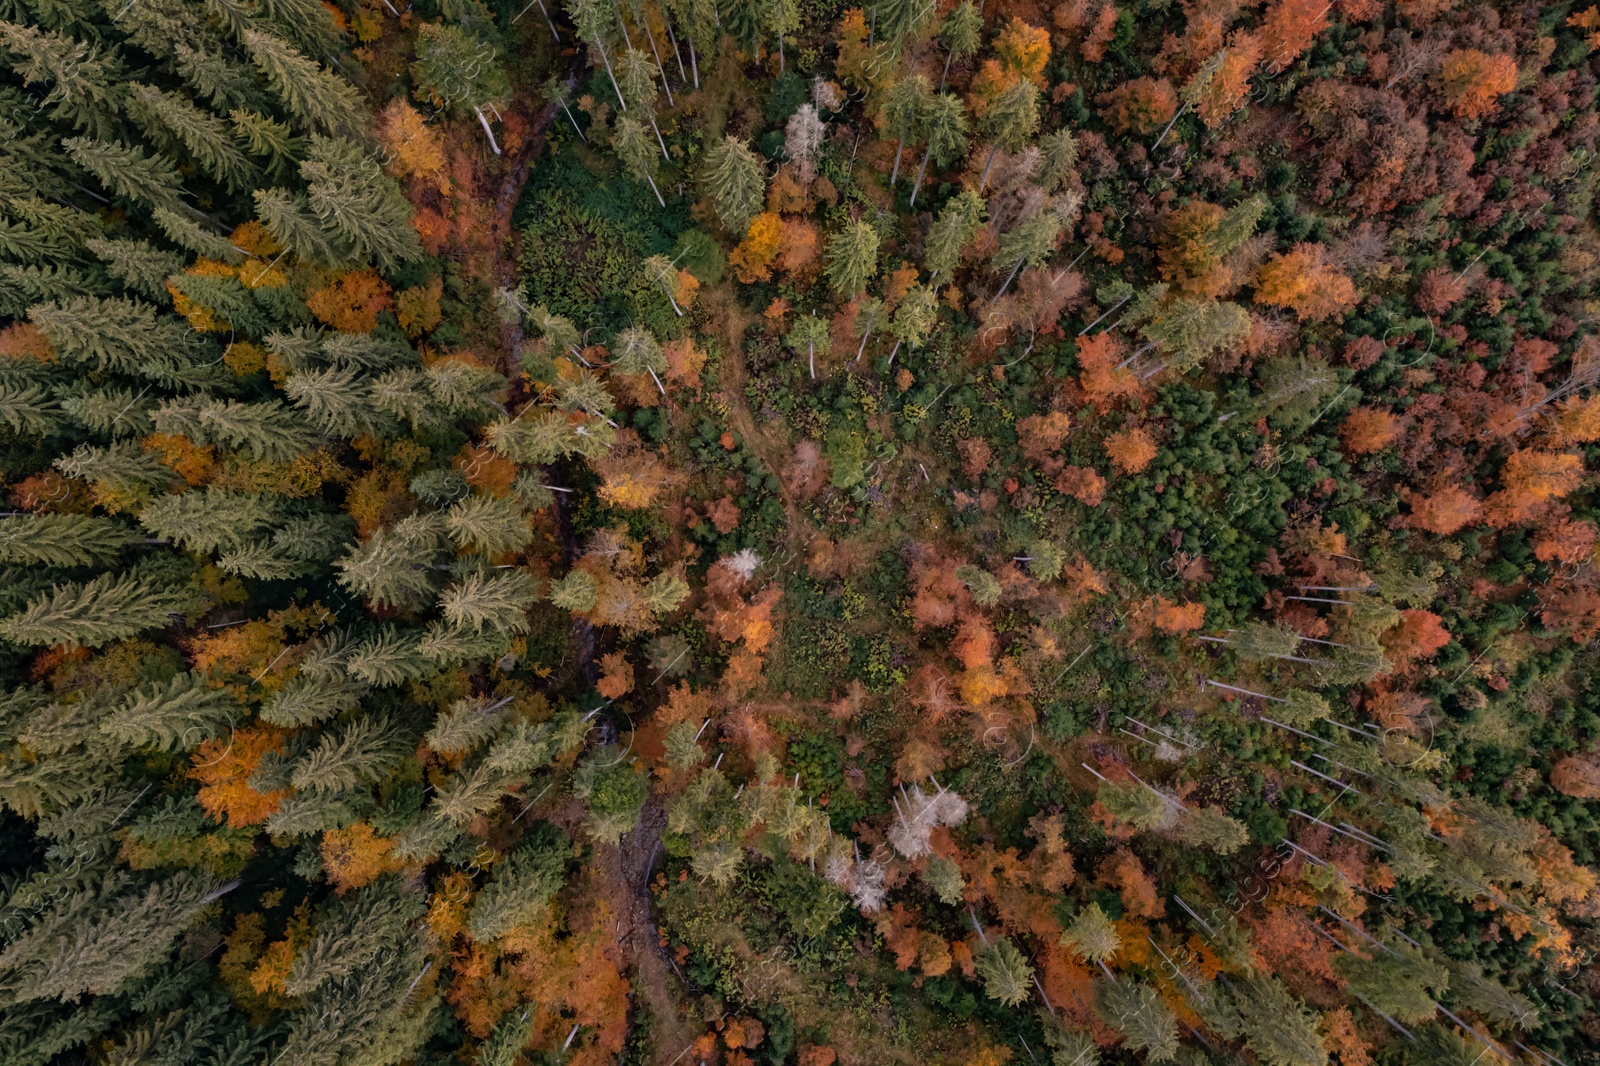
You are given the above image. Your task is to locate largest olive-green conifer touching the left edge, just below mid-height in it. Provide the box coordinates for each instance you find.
[0,573,190,648]
